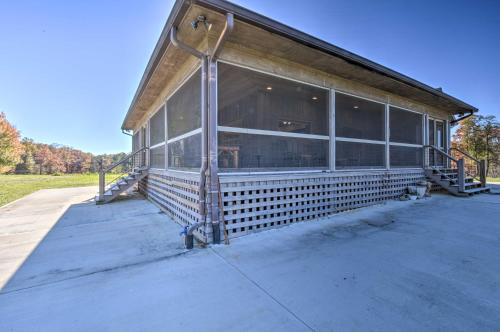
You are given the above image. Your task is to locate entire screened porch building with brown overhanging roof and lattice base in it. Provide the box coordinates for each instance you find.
[110,0,488,243]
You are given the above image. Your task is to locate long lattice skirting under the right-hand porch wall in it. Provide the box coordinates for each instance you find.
[220,169,425,238]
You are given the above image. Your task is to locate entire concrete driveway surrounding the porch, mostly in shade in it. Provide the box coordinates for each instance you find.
[0,188,500,331]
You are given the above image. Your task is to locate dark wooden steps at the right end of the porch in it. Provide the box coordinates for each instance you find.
[425,167,490,197]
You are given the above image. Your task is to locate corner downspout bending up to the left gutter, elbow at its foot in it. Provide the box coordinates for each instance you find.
[170,27,208,249]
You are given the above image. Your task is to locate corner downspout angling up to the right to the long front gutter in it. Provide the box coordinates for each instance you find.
[208,13,234,244]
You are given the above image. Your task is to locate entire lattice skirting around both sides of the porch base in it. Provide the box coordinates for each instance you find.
[139,169,425,241]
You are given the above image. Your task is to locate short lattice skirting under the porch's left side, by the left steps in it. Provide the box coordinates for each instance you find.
[139,170,207,242]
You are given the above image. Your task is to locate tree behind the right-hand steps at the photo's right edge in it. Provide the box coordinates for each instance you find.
[453,115,500,176]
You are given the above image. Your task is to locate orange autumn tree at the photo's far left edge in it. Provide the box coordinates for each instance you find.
[0,112,23,172]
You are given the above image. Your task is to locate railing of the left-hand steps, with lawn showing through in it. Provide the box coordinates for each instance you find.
[99,147,149,198]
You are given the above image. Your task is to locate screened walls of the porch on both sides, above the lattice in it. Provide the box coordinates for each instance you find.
[140,61,449,175]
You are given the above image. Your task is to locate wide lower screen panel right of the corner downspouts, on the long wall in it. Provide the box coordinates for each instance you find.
[218,132,329,171]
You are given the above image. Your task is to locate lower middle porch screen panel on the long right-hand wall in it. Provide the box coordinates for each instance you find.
[335,141,385,169]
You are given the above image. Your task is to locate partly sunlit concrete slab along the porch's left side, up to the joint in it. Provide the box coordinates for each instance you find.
[0,187,186,293]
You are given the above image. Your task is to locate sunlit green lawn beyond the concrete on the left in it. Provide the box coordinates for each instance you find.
[0,173,99,206]
